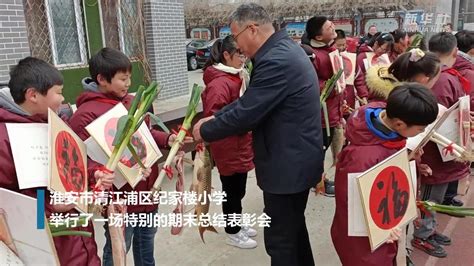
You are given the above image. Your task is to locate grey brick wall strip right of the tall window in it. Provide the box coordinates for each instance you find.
[144,0,189,99]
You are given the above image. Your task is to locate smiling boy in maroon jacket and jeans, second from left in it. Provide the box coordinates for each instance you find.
[70,48,191,265]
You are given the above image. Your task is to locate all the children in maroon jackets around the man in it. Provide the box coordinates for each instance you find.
[0,16,474,265]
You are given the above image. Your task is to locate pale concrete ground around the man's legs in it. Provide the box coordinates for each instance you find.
[95,151,340,265]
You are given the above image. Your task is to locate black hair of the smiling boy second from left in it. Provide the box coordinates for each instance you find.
[89,47,132,83]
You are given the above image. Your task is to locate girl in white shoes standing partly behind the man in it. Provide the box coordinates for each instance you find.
[202,36,257,248]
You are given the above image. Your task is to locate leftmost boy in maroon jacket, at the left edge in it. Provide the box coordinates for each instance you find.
[0,57,102,265]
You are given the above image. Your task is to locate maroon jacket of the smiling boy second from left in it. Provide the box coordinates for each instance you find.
[70,79,169,213]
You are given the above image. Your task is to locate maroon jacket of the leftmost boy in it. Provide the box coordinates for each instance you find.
[0,89,100,266]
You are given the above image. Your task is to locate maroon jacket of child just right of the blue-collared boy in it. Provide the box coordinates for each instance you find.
[421,67,469,184]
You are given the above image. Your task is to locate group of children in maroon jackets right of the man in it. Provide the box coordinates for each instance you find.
[302,16,474,265]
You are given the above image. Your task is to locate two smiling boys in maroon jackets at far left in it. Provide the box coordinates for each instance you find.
[0,48,180,265]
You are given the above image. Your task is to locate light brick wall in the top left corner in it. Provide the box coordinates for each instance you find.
[0,0,30,83]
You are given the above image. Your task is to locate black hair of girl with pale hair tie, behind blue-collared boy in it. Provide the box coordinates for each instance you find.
[388,52,440,81]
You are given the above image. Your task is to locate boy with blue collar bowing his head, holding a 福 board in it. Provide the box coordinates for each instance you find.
[331,83,438,266]
